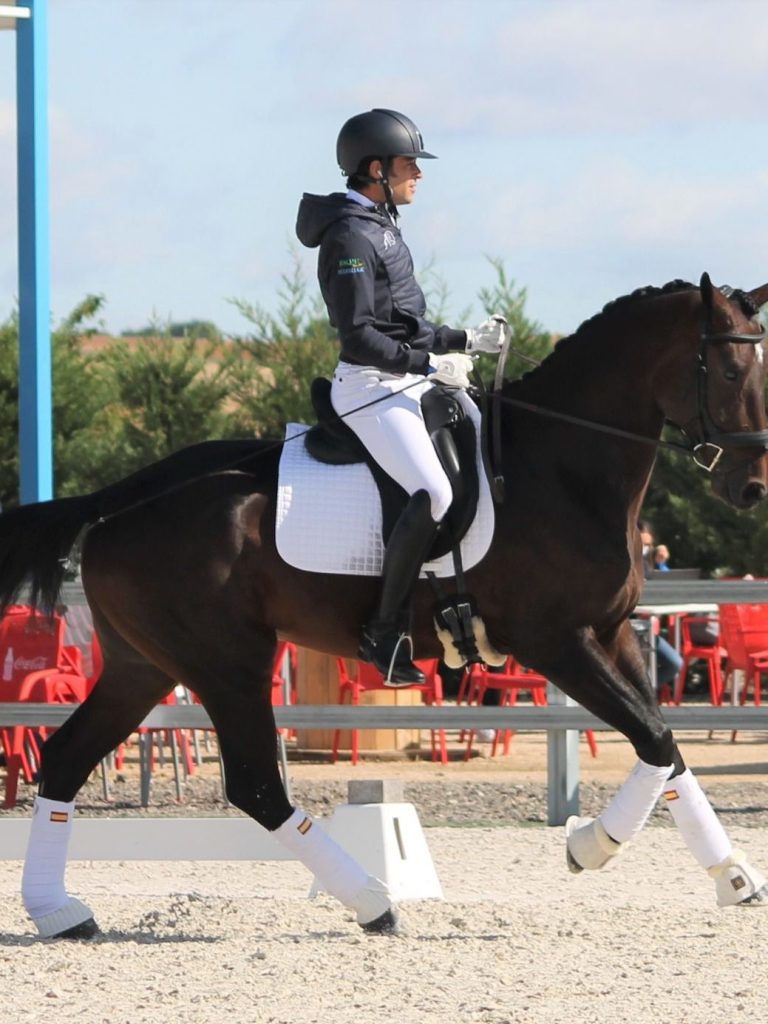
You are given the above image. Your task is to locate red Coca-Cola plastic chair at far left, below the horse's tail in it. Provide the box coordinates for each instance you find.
[0,605,88,808]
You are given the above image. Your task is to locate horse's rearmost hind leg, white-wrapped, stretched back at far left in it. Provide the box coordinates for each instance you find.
[22,628,173,938]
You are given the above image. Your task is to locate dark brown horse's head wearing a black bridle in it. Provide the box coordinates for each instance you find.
[676,273,768,509]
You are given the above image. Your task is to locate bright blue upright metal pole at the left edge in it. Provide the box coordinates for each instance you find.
[16,0,53,504]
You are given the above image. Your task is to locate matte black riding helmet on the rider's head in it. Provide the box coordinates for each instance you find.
[336,109,437,177]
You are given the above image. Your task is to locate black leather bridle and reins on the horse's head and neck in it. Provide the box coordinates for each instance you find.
[490,286,768,485]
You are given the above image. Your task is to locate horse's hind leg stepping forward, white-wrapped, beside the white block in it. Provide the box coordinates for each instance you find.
[195,671,396,932]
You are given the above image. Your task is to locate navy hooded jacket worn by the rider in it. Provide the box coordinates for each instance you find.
[296,193,466,374]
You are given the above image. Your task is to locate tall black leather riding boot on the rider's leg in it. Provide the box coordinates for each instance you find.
[359,490,437,686]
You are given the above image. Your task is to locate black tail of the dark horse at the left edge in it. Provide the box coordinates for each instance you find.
[0,493,98,615]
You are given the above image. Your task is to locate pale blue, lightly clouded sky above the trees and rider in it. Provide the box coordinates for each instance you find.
[0,0,768,334]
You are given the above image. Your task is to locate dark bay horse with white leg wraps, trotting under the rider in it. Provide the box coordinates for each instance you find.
[0,274,768,938]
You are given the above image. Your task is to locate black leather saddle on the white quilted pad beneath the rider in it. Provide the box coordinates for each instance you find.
[304,377,479,561]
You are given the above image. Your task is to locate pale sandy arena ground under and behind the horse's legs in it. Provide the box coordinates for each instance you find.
[0,733,768,1024]
